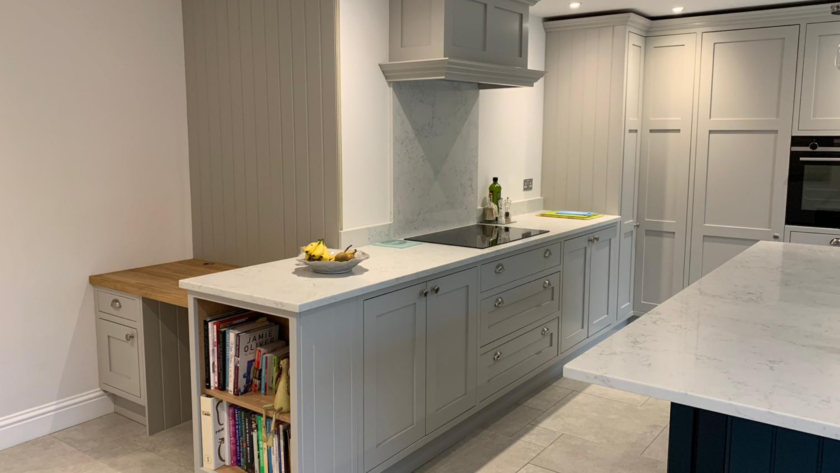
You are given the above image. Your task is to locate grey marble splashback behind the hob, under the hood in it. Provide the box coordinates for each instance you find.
[393,81,478,238]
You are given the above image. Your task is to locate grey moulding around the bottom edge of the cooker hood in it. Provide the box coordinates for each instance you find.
[379,58,545,88]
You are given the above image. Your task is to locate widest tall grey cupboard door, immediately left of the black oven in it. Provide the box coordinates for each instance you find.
[689,26,799,282]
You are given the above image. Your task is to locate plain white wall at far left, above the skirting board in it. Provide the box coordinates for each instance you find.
[0,0,192,420]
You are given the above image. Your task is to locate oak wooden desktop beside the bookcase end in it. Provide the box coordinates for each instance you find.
[89,259,237,307]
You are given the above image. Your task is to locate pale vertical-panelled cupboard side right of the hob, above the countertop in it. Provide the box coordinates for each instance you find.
[542,23,627,215]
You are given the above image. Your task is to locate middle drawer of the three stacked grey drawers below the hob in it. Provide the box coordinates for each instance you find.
[479,272,560,346]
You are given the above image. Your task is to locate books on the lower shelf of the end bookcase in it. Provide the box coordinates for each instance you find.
[201,396,291,473]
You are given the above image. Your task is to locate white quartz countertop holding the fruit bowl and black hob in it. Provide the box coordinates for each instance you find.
[180,212,619,312]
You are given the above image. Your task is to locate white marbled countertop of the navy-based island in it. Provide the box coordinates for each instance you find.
[564,242,840,439]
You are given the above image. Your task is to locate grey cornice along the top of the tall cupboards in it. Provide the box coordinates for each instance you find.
[543,3,840,35]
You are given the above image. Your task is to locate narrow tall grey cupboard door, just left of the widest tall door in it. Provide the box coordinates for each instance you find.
[634,33,697,313]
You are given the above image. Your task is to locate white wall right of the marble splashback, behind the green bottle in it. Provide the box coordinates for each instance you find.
[478,15,545,207]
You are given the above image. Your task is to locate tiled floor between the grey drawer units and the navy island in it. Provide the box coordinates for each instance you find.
[417,379,670,473]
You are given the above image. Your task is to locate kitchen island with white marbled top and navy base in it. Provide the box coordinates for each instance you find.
[564,242,840,473]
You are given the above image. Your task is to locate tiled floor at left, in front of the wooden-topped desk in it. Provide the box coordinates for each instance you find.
[0,414,193,473]
